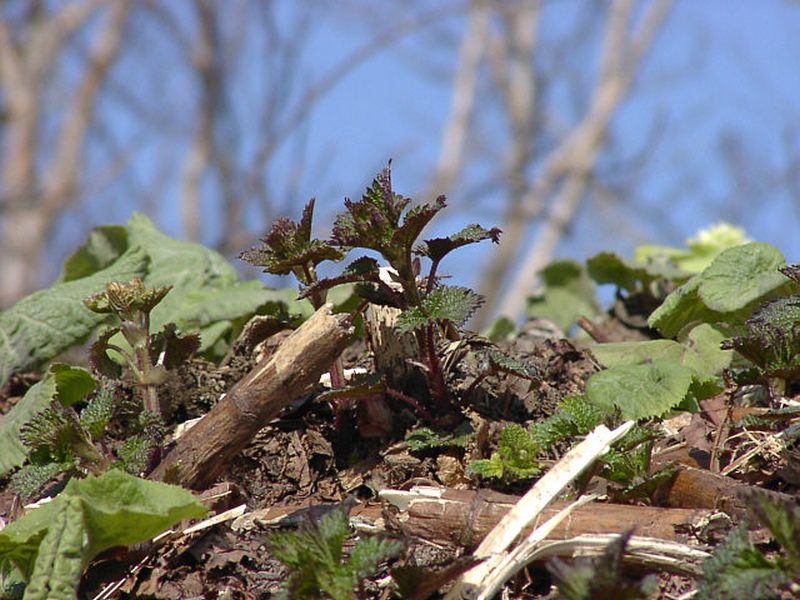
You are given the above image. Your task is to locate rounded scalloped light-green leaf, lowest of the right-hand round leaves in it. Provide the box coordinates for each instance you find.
[586,359,696,420]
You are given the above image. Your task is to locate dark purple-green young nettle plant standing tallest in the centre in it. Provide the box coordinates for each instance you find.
[242,164,501,426]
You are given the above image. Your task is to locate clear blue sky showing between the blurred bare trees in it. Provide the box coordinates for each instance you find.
[45,0,800,308]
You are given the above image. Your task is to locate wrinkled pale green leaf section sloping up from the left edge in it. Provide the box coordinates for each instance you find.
[0,247,147,387]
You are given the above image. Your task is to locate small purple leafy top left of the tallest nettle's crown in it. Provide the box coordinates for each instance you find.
[239,198,344,278]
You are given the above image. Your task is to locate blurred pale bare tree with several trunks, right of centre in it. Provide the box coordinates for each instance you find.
[433,0,673,329]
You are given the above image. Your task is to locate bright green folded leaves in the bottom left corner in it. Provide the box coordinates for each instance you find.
[0,470,206,599]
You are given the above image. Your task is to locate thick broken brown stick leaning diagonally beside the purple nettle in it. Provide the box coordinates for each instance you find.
[151,304,353,489]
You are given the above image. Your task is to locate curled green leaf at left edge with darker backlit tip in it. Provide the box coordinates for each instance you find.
[0,364,94,477]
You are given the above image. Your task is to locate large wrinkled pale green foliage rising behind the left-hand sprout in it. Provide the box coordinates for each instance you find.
[0,214,286,386]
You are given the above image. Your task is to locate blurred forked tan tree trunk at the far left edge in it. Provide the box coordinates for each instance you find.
[0,0,130,307]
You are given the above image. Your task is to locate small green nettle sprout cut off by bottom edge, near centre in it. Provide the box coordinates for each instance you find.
[266,509,403,600]
